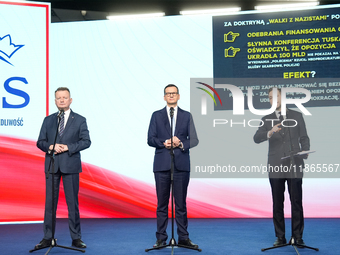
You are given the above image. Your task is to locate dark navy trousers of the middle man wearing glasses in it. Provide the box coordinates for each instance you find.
[154,170,190,240]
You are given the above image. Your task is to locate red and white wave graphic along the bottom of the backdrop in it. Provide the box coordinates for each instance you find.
[0,136,340,222]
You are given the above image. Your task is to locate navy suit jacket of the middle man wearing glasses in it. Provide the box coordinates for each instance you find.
[148,107,198,172]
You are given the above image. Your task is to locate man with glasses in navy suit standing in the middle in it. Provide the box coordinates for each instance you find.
[148,84,198,248]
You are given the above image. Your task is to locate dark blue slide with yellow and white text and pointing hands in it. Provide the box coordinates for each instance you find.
[213,7,340,109]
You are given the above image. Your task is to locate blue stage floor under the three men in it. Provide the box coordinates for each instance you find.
[0,219,340,255]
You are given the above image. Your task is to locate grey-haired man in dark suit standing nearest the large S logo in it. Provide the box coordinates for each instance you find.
[35,87,91,249]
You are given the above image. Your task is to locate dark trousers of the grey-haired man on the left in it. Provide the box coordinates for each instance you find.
[44,171,81,240]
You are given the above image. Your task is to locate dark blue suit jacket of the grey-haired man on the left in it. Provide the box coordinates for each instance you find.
[37,110,91,173]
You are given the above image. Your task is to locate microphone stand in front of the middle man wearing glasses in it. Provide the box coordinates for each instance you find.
[145,107,202,254]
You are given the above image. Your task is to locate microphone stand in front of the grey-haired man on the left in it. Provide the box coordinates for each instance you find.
[29,110,85,255]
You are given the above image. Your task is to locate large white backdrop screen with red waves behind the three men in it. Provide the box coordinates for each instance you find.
[0,1,340,222]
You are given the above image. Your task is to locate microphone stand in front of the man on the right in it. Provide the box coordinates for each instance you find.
[261,111,319,255]
